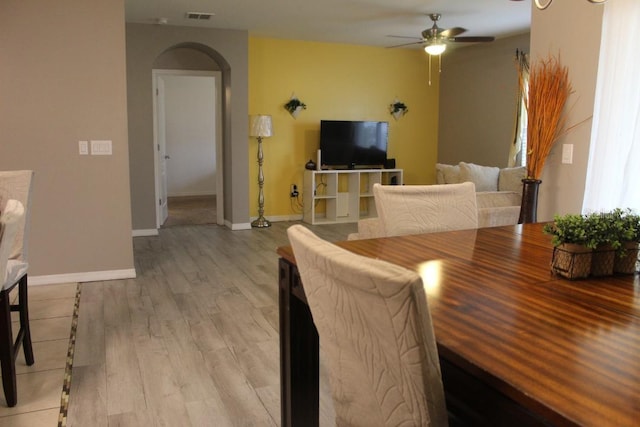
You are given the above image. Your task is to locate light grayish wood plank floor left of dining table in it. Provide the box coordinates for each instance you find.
[67,222,356,426]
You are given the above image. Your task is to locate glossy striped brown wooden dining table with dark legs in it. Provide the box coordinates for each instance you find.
[277,223,640,427]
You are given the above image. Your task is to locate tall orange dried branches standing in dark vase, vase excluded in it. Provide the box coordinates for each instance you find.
[527,56,571,179]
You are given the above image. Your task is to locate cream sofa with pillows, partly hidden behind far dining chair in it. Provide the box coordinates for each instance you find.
[348,162,526,240]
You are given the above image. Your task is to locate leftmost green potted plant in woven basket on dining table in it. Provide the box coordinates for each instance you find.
[543,214,599,279]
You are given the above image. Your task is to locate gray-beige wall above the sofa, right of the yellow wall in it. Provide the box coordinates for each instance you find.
[438,33,529,167]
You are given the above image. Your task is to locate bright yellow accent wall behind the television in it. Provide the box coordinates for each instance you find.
[248,38,439,219]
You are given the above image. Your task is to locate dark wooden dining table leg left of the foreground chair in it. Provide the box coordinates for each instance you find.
[279,259,320,427]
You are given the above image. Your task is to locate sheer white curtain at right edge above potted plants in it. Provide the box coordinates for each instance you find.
[582,0,640,212]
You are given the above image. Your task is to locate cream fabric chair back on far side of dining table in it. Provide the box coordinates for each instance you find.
[373,182,478,237]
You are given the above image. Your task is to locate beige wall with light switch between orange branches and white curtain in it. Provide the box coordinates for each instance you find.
[531,0,603,221]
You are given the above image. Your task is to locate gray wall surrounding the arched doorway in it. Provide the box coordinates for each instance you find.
[126,24,249,230]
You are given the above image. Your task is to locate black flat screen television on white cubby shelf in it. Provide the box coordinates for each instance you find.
[320,120,389,169]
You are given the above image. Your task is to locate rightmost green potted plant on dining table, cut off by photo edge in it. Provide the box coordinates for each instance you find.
[611,208,640,274]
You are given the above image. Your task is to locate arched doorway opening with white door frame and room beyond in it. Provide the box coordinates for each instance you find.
[152,44,224,228]
